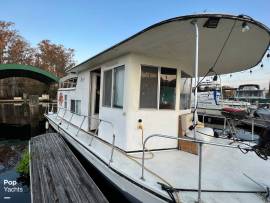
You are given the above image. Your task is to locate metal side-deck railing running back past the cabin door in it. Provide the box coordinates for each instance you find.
[46,103,115,164]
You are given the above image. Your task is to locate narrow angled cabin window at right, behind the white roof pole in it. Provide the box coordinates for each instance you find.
[180,71,192,110]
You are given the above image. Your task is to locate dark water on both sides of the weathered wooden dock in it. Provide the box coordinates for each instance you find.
[0,104,128,203]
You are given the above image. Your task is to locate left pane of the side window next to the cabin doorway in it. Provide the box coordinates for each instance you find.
[102,70,112,107]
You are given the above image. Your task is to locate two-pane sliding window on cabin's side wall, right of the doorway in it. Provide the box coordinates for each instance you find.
[102,66,125,108]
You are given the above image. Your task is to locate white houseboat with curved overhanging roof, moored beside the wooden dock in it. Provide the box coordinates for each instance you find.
[46,14,270,203]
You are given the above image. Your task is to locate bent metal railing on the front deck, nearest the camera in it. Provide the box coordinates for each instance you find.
[141,134,250,202]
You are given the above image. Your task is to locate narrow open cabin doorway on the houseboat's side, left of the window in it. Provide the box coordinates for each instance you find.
[89,71,100,130]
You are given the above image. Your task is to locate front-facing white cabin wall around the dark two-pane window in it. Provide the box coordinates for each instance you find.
[125,54,192,151]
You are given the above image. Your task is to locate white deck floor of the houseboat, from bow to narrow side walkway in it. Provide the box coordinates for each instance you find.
[48,115,270,203]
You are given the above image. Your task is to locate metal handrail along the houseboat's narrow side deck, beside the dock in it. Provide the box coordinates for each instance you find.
[46,104,115,164]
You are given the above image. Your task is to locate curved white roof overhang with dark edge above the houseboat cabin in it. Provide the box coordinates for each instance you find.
[68,14,270,75]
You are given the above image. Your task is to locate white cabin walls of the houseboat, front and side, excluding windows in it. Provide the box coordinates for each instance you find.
[58,54,192,151]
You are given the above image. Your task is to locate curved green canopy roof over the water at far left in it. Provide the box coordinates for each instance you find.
[0,64,59,84]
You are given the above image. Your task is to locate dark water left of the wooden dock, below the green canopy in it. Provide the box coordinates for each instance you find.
[0,103,45,203]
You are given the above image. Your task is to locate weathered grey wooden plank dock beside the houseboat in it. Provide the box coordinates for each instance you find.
[29,133,108,203]
